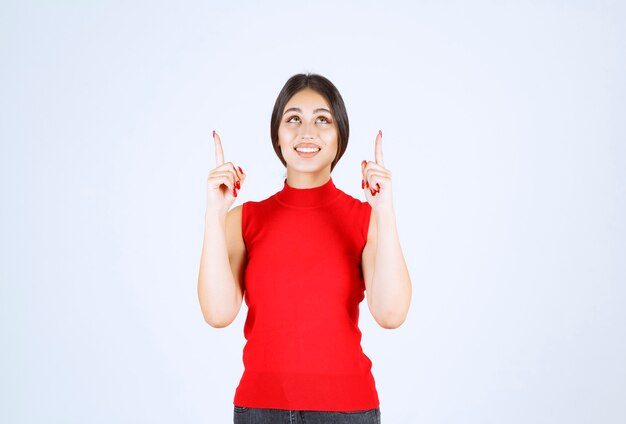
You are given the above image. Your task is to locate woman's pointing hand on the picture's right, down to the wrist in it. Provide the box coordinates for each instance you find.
[361,131,392,212]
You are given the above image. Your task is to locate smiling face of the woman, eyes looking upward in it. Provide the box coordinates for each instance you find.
[278,88,338,174]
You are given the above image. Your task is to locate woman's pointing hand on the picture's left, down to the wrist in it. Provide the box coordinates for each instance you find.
[207,131,246,217]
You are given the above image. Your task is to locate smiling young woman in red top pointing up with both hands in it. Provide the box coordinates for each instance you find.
[198,74,411,424]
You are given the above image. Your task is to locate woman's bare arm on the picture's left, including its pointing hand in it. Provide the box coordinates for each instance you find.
[198,132,246,328]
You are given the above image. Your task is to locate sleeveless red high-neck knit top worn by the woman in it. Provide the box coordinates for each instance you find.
[234,179,379,411]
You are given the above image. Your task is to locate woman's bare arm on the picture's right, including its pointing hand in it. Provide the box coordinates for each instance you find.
[361,131,411,328]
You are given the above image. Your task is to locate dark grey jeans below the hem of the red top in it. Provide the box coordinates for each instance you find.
[233,406,380,424]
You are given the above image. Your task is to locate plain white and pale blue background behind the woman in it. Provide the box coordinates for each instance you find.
[0,1,626,424]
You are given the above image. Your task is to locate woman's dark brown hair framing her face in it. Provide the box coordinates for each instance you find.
[270,74,350,171]
